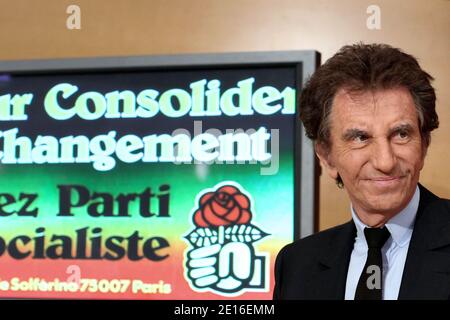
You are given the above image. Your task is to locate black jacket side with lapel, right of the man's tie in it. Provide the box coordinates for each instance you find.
[399,185,450,299]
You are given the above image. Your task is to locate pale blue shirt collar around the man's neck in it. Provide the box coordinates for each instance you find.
[350,186,420,247]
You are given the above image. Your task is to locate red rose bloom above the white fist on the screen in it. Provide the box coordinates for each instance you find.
[194,185,252,228]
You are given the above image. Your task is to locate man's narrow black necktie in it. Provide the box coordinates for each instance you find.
[355,227,391,300]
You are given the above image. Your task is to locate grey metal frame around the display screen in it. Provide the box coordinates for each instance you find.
[0,50,320,240]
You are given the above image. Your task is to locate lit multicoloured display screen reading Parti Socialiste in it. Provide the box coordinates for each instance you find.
[0,65,298,299]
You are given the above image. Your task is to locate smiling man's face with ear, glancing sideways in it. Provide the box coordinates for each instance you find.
[318,88,426,222]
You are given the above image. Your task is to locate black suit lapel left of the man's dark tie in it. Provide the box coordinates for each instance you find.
[308,221,356,299]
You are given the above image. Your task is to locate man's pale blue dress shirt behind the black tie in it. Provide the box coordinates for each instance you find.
[345,187,420,300]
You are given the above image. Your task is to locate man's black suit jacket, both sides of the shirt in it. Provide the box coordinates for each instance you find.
[273,185,450,300]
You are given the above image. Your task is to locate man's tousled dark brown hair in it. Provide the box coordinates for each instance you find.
[299,43,439,149]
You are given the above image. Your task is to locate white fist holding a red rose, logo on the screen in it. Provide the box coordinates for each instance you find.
[185,182,268,296]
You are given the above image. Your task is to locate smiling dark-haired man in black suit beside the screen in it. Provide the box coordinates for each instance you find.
[274,44,450,300]
